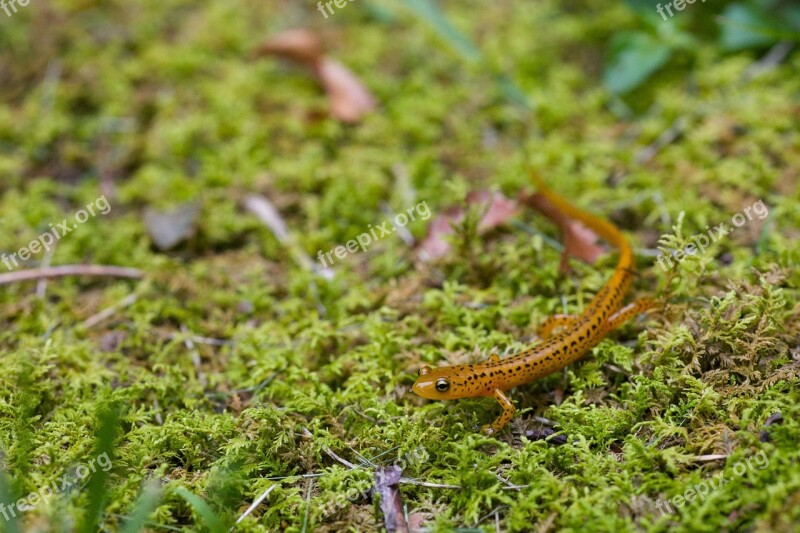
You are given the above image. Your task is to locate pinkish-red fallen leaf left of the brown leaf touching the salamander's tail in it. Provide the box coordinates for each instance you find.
[420,190,519,261]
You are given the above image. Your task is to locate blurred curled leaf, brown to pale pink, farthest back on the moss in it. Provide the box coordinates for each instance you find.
[256,29,376,123]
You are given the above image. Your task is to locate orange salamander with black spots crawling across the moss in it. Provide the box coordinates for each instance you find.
[413,175,656,435]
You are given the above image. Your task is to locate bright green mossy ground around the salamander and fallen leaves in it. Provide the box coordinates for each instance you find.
[0,0,800,531]
